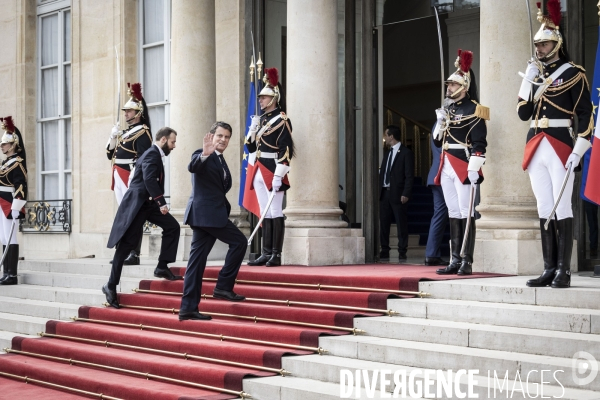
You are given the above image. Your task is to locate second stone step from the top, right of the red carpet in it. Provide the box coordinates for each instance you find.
[388,298,600,334]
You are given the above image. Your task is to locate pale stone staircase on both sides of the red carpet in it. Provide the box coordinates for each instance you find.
[0,259,600,400]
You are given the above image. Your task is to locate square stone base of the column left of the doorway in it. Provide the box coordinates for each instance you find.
[282,227,365,266]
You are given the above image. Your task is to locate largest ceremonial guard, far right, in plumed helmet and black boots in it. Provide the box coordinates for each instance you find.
[517,0,593,288]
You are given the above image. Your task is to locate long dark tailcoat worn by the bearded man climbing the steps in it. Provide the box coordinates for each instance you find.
[108,145,167,248]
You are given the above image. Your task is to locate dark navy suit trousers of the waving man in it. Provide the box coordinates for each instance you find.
[180,220,248,312]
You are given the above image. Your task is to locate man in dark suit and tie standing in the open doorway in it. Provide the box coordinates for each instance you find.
[379,125,415,261]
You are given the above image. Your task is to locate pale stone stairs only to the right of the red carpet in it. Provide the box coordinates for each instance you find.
[244,276,600,400]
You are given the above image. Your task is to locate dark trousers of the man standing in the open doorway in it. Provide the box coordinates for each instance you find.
[379,189,408,255]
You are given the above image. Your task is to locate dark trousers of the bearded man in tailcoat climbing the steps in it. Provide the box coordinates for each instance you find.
[108,201,181,290]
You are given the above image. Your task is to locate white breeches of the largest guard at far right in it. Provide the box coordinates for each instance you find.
[527,138,575,219]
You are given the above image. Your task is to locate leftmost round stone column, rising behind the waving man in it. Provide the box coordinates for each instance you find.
[170,0,216,259]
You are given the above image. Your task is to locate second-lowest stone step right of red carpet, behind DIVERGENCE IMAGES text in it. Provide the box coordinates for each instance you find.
[282,355,600,400]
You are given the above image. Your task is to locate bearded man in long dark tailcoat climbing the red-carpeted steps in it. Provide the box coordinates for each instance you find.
[102,127,182,308]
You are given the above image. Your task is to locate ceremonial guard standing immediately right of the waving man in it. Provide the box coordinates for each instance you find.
[246,68,294,267]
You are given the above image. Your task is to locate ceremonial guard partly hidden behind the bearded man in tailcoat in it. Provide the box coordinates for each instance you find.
[106,83,152,265]
